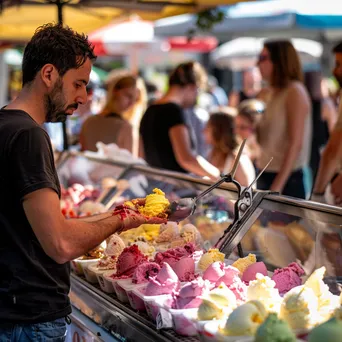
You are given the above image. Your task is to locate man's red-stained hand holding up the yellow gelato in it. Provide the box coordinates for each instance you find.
[113,198,167,233]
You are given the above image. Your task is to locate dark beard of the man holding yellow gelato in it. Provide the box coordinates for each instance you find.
[45,78,78,122]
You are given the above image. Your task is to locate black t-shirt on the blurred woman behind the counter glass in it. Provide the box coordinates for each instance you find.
[140,103,187,172]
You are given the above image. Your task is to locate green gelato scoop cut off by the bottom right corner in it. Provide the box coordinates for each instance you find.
[309,317,342,342]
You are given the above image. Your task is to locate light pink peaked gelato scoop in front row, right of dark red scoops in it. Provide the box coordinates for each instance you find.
[145,263,180,296]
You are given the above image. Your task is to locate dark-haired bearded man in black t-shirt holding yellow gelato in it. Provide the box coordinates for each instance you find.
[0,24,166,342]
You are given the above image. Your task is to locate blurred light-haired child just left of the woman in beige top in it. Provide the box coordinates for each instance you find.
[235,99,265,163]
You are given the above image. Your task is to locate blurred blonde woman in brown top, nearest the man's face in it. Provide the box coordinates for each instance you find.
[80,70,138,153]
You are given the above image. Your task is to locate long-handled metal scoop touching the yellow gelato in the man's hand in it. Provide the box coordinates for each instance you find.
[168,140,246,222]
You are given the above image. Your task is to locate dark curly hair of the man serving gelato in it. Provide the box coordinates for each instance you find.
[22,24,96,86]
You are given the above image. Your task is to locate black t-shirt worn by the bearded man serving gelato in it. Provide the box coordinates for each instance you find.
[0,109,71,323]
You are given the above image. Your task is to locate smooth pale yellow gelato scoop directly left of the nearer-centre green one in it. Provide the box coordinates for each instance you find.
[223,300,267,336]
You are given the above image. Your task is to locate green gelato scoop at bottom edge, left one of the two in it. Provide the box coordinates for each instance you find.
[255,313,297,342]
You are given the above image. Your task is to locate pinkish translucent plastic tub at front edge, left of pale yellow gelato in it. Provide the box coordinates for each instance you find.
[169,309,198,337]
